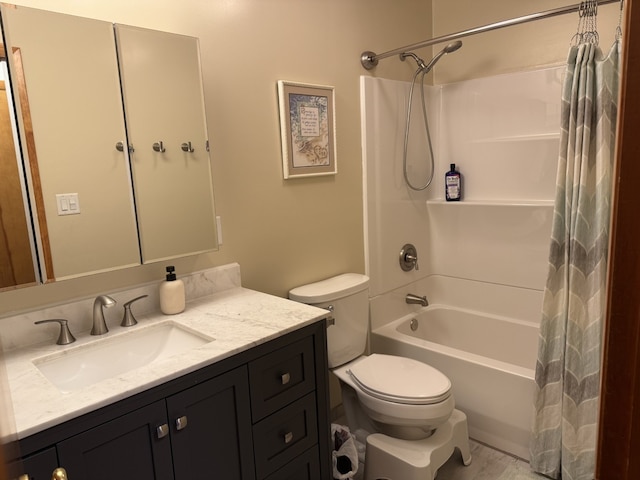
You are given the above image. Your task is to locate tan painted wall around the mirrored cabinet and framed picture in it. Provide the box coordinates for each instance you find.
[0,0,431,315]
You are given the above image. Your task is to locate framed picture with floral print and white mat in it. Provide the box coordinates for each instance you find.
[278,80,338,178]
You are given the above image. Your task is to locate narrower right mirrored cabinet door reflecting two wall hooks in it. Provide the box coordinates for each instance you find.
[115,25,216,263]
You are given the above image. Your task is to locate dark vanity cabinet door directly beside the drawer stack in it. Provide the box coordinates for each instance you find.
[167,366,255,480]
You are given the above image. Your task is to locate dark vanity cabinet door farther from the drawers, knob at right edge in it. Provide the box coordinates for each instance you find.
[57,401,174,480]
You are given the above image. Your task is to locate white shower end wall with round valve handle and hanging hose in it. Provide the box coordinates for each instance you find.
[361,77,440,297]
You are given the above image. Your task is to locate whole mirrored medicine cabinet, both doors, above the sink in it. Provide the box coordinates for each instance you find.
[0,4,217,281]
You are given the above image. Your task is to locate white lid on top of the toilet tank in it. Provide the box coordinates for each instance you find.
[289,273,369,304]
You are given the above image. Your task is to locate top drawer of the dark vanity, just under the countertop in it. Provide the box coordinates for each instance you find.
[249,337,316,423]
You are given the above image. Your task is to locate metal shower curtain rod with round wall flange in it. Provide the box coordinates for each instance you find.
[360,0,621,70]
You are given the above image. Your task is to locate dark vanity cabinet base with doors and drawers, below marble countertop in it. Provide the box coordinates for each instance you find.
[16,321,331,480]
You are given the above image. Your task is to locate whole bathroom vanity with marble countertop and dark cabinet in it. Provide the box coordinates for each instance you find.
[6,266,331,480]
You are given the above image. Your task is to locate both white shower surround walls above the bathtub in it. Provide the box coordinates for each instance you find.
[363,65,562,297]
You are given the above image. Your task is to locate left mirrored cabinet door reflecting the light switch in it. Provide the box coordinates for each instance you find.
[2,5,140,280]
